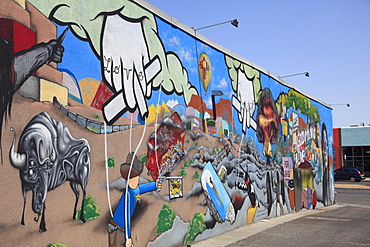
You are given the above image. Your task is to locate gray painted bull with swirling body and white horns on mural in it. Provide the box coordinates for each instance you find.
[9,112,90,232]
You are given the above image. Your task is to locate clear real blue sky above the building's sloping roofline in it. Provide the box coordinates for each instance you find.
[148,0,370,127]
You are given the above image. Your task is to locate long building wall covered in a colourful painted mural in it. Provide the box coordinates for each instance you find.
[0,0,334,246]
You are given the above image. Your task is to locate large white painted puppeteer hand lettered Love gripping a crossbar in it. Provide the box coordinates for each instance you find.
[101,15,161,124]
